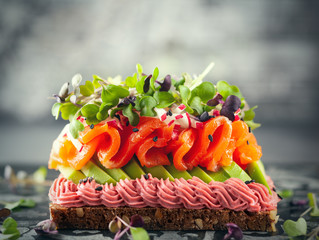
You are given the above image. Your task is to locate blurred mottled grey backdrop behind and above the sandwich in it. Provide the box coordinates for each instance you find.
[0,0,319,165]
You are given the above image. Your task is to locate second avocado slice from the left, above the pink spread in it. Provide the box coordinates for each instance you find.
[81,161,116,185]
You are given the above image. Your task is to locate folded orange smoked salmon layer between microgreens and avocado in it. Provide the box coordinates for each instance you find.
[49,116,262,171]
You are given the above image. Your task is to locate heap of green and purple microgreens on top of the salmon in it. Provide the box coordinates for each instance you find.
[52,63,260,139]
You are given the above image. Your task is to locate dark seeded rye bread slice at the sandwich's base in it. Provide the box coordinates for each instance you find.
[50,203,278,232]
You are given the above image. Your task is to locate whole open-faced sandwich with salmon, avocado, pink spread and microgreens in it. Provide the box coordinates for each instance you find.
[49,64,279,231]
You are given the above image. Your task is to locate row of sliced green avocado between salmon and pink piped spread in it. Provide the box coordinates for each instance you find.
[59,156,271,190]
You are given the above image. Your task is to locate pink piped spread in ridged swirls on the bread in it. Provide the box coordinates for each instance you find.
[49,174,279,212]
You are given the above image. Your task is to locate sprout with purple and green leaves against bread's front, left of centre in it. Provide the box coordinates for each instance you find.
[109,215,149,240]
